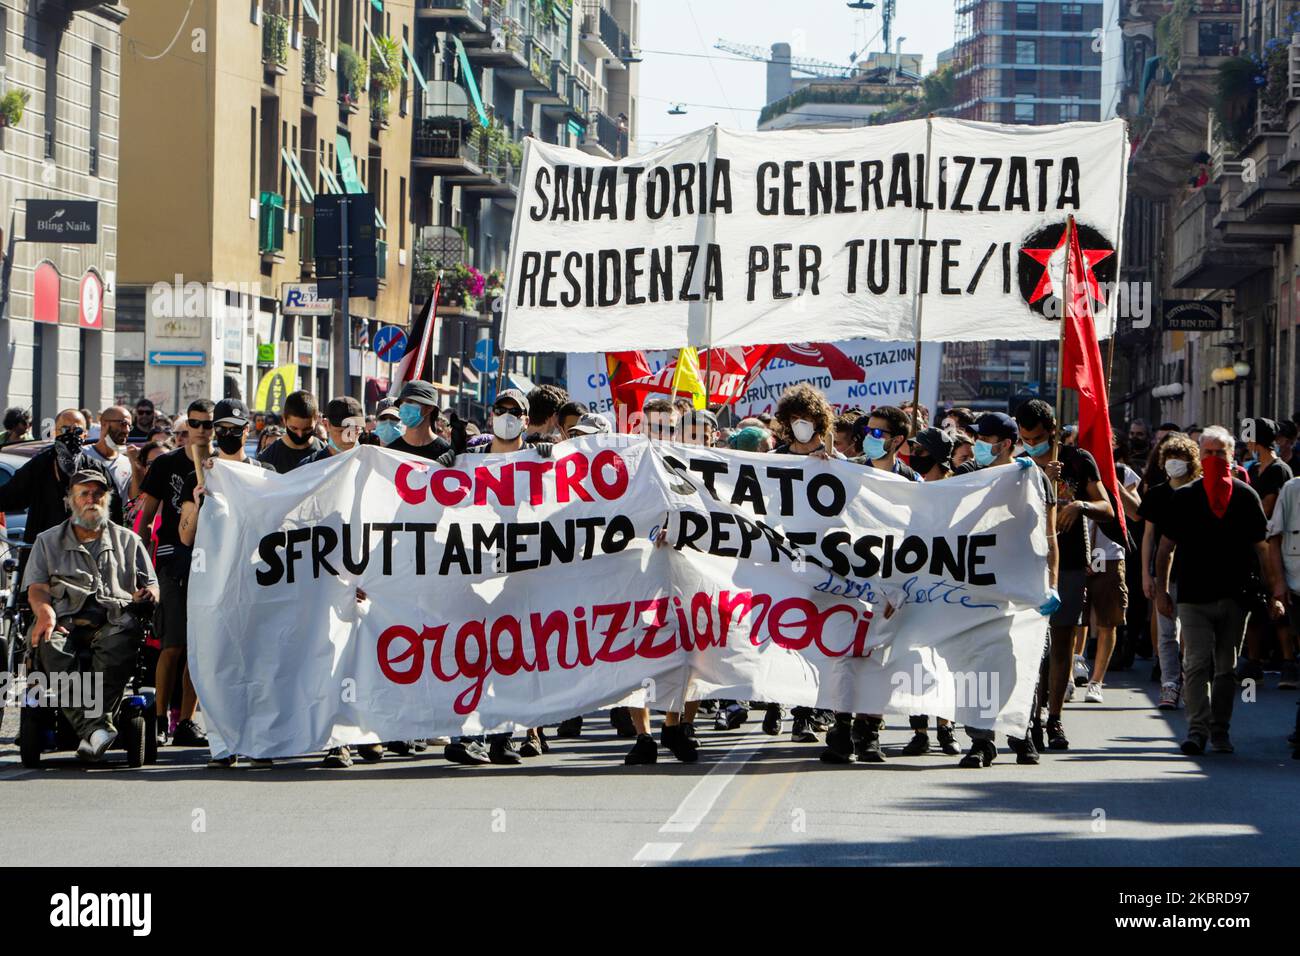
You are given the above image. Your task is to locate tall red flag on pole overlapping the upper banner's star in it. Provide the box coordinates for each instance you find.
[1061,217,1127,533]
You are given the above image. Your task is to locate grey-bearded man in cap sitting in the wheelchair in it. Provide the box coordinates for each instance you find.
[23,470,159,761]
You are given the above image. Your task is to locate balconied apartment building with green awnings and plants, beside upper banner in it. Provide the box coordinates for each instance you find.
[411,0,640,415]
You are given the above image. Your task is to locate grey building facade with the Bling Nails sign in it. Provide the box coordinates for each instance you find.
[0,0,127,423]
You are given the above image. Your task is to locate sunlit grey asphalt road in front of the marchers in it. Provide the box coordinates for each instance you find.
[0,661,1300,866]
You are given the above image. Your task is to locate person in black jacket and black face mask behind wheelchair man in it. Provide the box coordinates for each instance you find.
[0,408,126,574]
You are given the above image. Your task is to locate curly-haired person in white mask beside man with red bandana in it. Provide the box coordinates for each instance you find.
[1138,433,1201,710]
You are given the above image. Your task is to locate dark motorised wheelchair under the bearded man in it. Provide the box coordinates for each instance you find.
[10,604,159,769]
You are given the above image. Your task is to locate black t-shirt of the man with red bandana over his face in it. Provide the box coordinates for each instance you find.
[1164,479,1268,604]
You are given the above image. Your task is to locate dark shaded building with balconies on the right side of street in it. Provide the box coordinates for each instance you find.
[1113,0,1300,427]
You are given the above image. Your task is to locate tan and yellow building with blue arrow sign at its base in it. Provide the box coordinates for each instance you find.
[117,0,410,411]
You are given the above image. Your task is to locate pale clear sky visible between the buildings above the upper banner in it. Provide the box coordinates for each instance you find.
[637,0,954,150]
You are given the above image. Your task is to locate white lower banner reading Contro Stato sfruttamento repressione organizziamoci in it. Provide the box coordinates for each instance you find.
[189,436,1048,757]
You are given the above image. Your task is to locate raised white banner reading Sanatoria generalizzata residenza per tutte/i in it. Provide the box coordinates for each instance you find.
[503,118,1127,351]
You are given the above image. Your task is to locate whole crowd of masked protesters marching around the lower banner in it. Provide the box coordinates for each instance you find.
[0,381,1300,767]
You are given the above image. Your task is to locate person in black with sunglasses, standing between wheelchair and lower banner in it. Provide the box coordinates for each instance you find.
[137,398,215,747]
